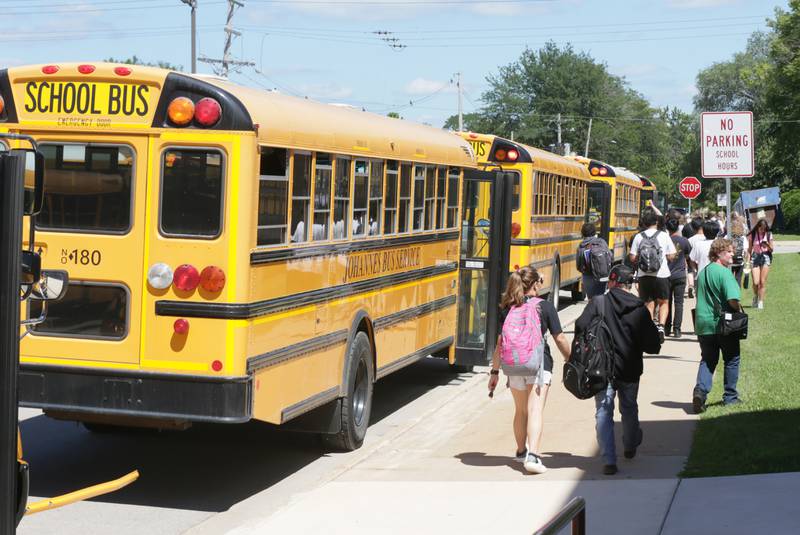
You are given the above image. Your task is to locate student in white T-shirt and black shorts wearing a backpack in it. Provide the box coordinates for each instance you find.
[630,210,676,343]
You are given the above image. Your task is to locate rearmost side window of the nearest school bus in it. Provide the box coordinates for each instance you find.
[256,147,289,245]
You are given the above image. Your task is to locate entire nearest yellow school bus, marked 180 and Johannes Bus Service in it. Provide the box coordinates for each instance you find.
[0,63,475,449]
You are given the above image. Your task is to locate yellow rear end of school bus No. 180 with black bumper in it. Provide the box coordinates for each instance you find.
[0,64,256,427]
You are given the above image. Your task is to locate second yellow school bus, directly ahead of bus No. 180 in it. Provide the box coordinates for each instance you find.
[462,132,591,306]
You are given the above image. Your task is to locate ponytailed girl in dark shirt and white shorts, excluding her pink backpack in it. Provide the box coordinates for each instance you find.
[489,266,570,474]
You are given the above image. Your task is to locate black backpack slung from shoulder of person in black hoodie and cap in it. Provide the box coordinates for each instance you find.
[564,295,614,399]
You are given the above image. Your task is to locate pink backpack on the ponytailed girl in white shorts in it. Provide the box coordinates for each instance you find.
[500,297,545,384]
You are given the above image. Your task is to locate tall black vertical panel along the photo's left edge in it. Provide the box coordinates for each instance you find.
[0,154,25,535]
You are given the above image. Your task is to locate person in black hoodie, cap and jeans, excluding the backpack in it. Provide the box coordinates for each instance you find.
[575,264,661,475]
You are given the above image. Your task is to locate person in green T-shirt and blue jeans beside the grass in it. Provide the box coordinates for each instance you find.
[692,238,742,414]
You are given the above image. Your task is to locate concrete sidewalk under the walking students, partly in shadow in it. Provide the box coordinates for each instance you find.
[209,300,800,535]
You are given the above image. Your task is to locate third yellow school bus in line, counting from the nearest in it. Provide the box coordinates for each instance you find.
[572,156,642,263]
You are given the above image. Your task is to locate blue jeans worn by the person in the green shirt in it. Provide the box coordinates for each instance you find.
[694,334,740,403]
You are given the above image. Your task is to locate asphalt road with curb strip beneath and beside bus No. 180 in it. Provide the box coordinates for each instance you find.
[18,298,578,535]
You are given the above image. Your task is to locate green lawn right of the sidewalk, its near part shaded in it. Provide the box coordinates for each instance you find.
[682,255,800,477]
